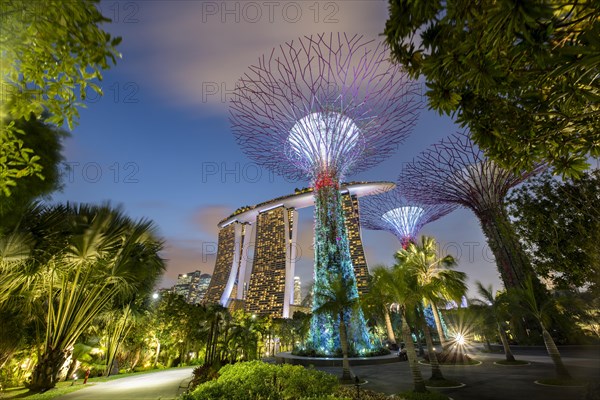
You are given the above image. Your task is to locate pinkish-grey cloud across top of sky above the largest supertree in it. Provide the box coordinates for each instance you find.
[112,0,387,111]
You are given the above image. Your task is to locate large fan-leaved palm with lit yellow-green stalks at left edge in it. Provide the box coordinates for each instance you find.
[0,205,164,391]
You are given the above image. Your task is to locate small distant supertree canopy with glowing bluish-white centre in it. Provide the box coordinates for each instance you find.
[360,186,458,248]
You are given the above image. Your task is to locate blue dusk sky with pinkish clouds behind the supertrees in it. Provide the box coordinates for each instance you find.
[52,0,501,295]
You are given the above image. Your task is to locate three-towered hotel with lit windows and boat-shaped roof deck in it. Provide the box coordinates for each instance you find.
[204,182,394,318]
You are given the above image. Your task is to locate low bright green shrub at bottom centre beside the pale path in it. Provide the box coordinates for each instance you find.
[183,361,337,400]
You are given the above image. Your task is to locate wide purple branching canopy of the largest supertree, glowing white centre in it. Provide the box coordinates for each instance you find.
[230,34,421,181]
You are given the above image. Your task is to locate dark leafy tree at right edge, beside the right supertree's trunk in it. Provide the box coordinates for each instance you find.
[509,169,600,289]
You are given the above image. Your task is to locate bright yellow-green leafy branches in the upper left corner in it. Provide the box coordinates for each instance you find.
[0,0,121,196]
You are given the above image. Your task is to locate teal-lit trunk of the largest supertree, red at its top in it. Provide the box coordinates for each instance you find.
[310,180,371,354]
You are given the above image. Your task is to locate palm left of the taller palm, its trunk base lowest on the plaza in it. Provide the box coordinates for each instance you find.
[373,264,427,393]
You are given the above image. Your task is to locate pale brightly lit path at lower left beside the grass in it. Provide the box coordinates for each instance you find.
[58,367,194,400]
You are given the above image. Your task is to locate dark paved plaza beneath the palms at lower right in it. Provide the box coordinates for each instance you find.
[317,346,600,400]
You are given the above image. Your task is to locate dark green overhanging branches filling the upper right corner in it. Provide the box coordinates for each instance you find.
[385,0,600,176]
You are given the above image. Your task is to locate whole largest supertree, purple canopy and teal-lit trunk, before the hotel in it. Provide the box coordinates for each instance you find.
[230,34,421,354]
